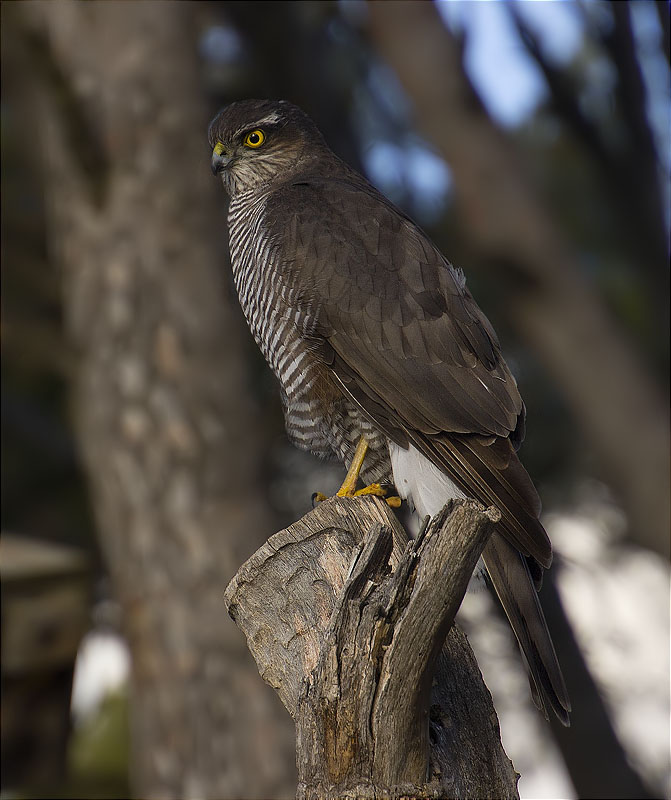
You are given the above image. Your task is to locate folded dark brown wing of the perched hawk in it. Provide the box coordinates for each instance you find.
[266,178,551,566]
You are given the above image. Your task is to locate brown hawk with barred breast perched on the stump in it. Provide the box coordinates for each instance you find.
[209,95,570,725]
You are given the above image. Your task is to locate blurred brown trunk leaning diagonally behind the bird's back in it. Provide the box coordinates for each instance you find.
[368,3,669,554]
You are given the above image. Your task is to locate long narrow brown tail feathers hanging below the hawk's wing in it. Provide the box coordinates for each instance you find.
[482,533,571,727]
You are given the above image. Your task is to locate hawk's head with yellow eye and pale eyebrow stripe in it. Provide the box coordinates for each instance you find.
[208,100,330,195]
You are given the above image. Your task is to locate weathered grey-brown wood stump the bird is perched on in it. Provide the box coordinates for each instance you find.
[225,498,518,800]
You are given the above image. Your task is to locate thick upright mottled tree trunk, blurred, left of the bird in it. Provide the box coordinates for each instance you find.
[23,2,294,798]
